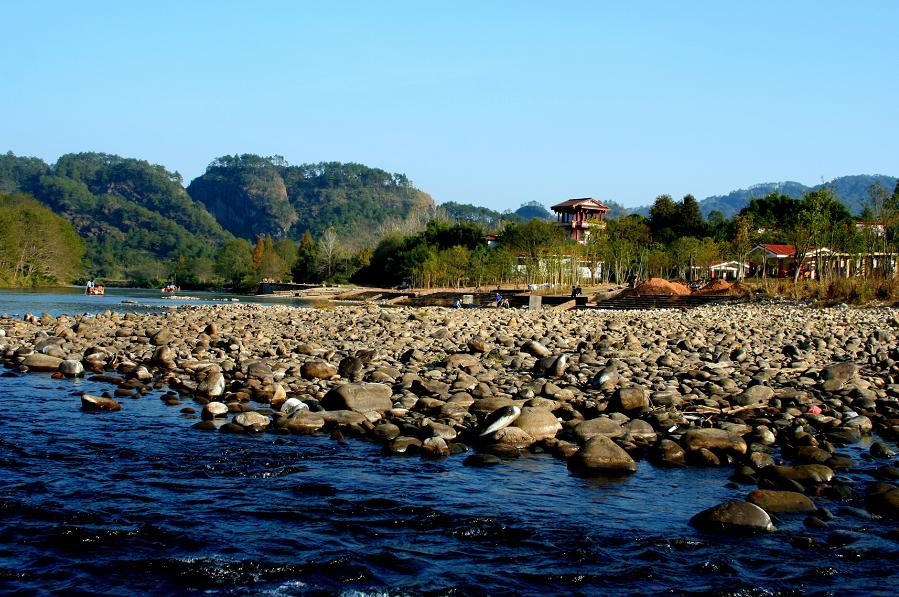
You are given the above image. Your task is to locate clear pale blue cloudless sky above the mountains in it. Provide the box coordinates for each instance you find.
[0,0,899,210]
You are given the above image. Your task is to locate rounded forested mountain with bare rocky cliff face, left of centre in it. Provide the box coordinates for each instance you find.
[187,154,434,246]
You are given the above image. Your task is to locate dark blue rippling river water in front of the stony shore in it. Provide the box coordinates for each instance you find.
[0,292,899,595]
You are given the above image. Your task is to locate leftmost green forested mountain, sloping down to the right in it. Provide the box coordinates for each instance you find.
[0,153,231,279]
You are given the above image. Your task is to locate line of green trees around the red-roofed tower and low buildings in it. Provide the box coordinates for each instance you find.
[213,184,899,288]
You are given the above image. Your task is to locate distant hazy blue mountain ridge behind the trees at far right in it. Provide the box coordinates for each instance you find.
[699,174,896,218]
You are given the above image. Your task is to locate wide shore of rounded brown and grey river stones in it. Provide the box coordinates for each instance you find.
[0,304,899,532]
